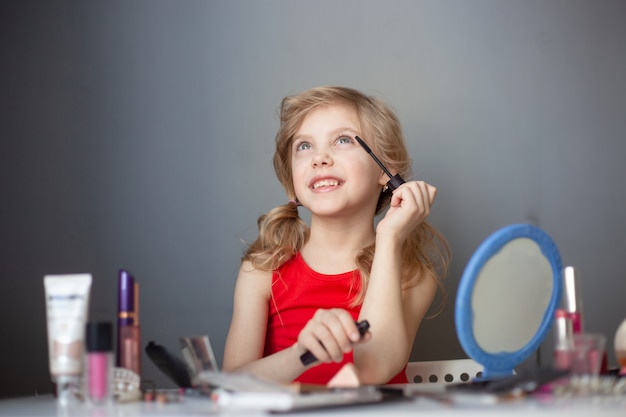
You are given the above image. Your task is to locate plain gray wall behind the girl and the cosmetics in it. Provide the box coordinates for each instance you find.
[0,0,626,397]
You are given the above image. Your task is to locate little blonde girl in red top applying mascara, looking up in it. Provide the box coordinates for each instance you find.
[223,87,449,384]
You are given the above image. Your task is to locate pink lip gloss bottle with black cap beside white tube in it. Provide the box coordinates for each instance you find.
[86,322,113,405]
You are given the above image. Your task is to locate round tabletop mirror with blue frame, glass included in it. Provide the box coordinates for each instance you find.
[455,224,563,379]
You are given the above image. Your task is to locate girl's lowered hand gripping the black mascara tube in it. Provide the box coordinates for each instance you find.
[296,309,371,362]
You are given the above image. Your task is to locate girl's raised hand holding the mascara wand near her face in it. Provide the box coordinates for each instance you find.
[376,181,437,241]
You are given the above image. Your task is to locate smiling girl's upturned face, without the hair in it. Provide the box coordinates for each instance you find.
[291,105,388,215]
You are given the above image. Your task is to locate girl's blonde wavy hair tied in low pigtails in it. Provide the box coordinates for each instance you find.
[243,87,450,307]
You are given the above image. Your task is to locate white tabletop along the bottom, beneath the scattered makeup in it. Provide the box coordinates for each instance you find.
[0,395,626,417]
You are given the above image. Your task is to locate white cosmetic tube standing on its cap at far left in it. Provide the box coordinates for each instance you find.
[44,274,92,404]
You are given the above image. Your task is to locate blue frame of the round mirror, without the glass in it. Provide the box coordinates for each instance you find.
[455,224,563,379]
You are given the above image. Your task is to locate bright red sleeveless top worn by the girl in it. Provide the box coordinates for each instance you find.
[264,252,408,384]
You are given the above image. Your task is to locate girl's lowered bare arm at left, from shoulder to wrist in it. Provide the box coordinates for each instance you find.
[222,261,307,383]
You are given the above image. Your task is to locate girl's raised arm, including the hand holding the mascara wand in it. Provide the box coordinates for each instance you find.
[354,182,437,383]
